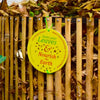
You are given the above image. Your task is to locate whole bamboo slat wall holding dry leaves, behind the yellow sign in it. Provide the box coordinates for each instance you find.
[0,16,100,100]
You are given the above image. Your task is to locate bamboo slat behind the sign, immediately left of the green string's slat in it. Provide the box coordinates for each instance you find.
[37,17,44,100]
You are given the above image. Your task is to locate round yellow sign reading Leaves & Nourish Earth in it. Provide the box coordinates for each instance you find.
[27,29,68,73]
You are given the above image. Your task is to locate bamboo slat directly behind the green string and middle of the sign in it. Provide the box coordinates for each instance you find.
[47,17,53,100]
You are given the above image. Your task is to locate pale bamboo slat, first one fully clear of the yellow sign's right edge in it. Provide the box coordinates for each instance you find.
[76,18,82,100]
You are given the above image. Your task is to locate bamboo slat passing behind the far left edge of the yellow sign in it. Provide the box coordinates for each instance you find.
[29,17,33,100]
